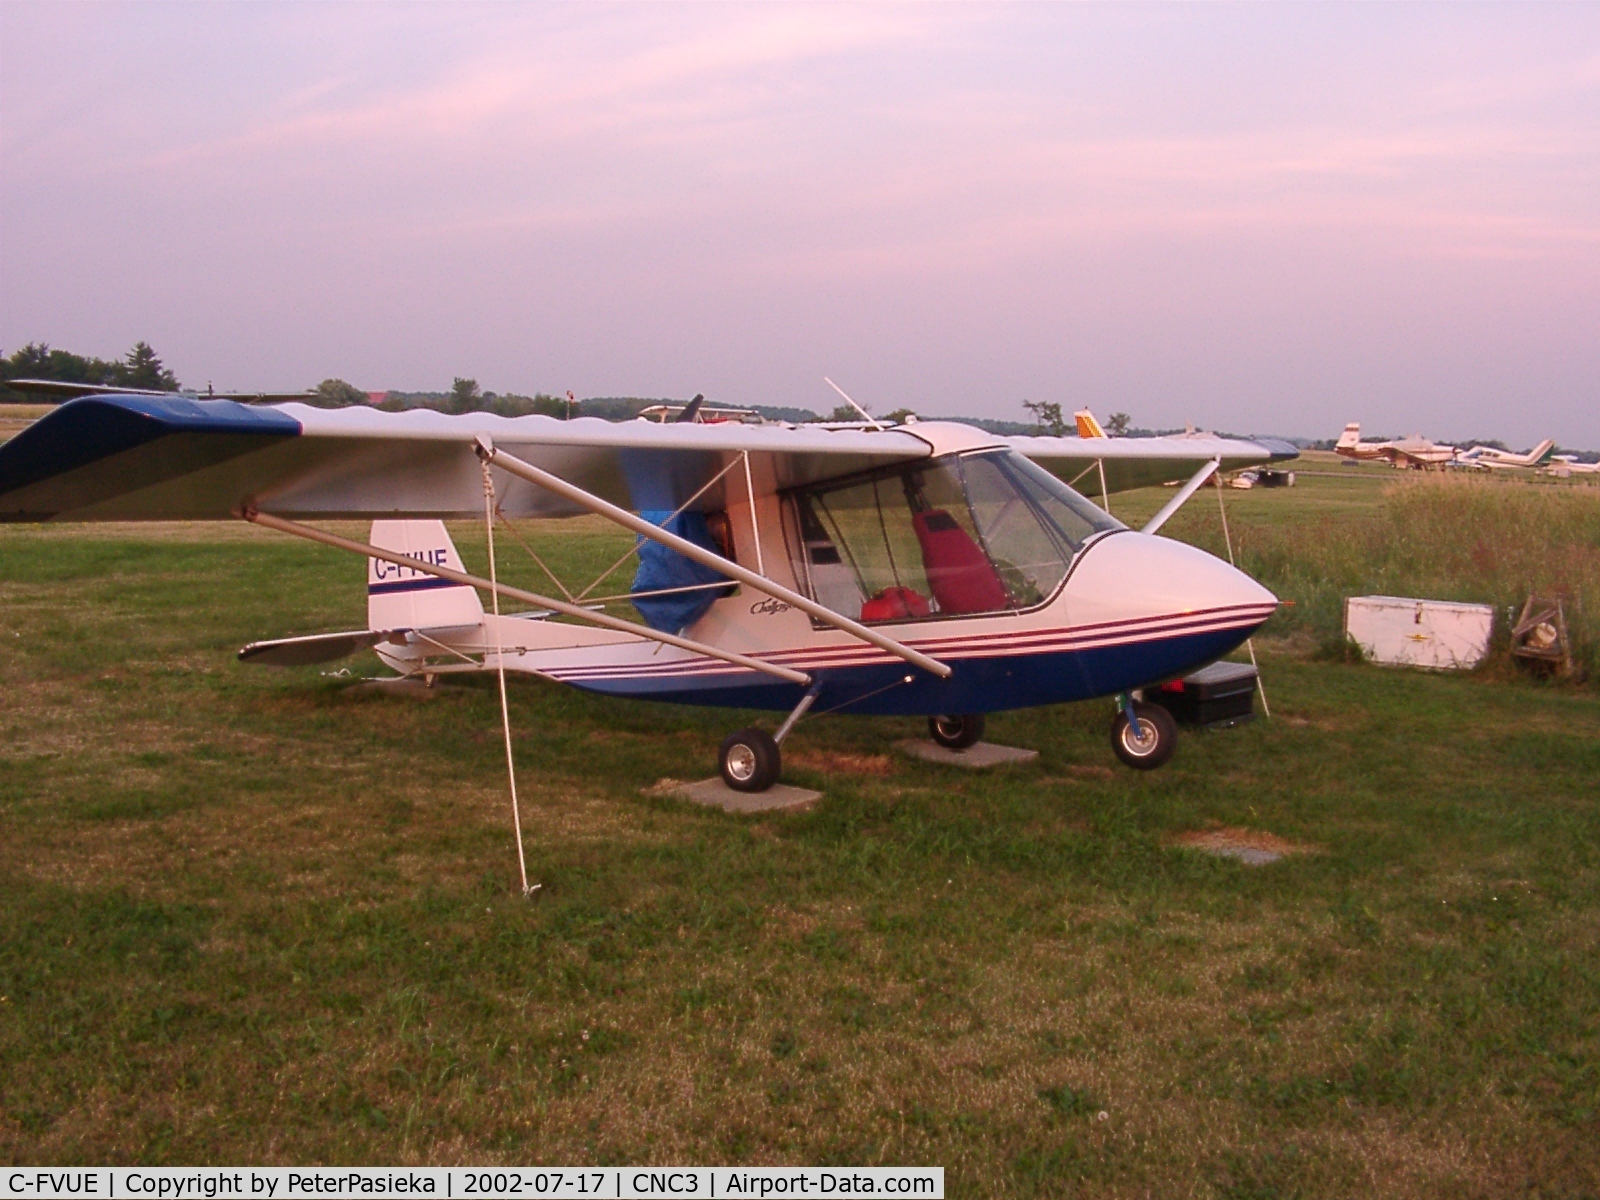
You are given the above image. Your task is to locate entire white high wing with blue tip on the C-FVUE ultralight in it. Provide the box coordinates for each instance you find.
[0,394,1293,522]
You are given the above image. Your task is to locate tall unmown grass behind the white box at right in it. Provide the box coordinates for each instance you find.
[1216,475,1600,680]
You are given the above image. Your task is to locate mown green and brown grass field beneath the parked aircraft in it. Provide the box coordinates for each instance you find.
[0,467,1600,1200]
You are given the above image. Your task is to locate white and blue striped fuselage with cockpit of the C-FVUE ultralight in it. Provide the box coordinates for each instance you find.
[374,430,1277,715]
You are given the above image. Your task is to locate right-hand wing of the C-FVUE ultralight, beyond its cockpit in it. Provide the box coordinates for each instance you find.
[1003,437,1299,498]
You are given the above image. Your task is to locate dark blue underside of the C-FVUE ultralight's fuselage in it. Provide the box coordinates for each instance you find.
[571,629,1254,717]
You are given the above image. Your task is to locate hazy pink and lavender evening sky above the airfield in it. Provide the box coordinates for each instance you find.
[0,0,1600,446]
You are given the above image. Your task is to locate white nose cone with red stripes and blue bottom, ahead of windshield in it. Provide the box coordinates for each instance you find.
[1066,531,1278,691]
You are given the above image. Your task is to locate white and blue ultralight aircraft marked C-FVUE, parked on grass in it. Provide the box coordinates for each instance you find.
[0,392,1294,792]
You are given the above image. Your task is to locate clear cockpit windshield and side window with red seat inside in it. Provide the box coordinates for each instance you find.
[794,450,1123,622]
